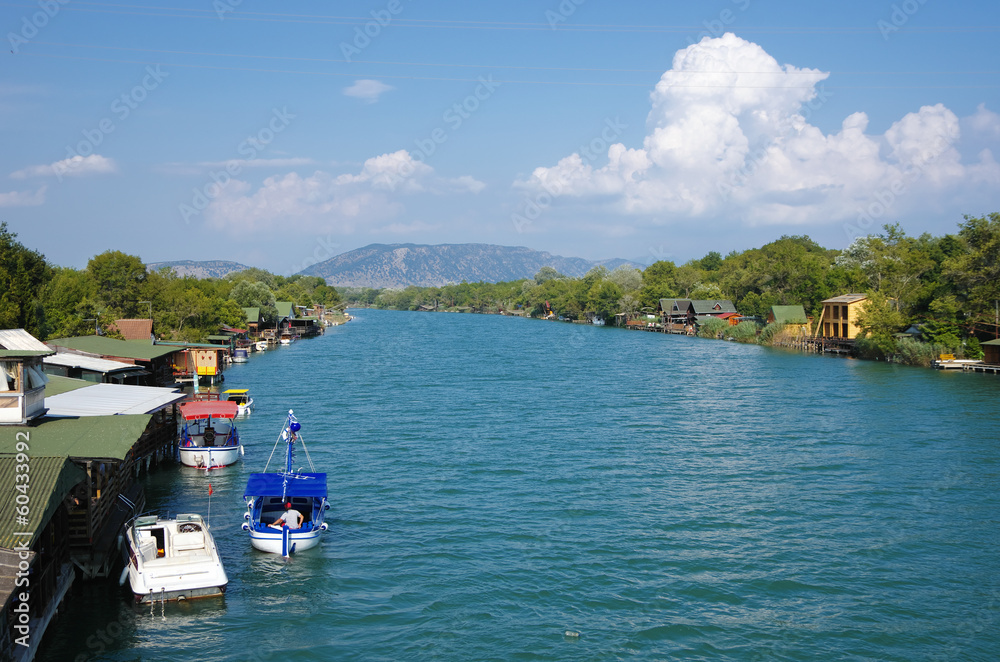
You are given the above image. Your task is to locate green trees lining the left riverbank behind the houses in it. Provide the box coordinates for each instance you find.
[0,223,341,342]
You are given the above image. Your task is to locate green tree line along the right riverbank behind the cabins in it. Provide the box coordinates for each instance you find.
[342,213,1000,358]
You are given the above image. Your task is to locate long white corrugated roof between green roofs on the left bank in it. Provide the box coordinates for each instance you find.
[45,384,187,417]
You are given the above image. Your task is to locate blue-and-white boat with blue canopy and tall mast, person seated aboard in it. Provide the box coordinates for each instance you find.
[243,409,330,557]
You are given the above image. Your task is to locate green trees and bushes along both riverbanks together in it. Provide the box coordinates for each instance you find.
[0,213,1000,366]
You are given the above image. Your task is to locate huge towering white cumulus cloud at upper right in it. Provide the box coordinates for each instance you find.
[515,33,1000,231]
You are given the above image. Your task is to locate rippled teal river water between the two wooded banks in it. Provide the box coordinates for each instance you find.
[35,310,1000,662]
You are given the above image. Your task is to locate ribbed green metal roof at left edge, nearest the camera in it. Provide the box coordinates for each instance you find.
[0,456,87,548]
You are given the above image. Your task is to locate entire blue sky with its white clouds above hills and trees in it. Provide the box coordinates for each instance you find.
[0,0,1000,274]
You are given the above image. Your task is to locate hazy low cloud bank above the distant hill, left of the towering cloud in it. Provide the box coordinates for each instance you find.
[206,150,485,233]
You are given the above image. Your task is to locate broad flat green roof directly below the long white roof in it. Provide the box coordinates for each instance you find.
[0,414,151,464]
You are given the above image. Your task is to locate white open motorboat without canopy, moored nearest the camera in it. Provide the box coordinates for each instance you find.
[119,515,229,603]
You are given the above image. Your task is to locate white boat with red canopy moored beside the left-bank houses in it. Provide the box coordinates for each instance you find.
[177,400,243,469]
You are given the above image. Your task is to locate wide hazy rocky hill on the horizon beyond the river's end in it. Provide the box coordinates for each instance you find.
[300,244,638,288]
